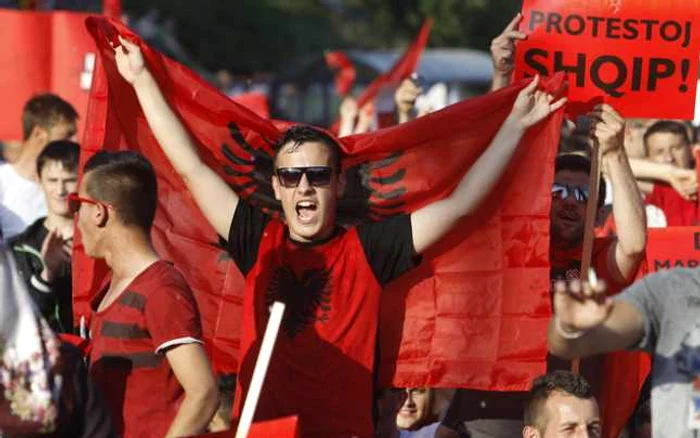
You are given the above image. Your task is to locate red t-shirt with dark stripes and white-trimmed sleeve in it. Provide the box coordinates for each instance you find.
[90,260,201,438]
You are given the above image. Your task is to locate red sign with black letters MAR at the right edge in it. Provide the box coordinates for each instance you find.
[647,227,700,273]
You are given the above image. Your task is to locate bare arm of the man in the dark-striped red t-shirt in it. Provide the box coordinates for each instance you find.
[165,344,219,438]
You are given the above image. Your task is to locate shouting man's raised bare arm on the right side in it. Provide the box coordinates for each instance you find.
[411,77,566,254]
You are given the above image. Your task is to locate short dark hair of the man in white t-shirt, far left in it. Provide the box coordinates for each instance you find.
[22,93,78,140]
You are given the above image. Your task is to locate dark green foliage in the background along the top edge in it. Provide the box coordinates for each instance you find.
[124,0,520,73]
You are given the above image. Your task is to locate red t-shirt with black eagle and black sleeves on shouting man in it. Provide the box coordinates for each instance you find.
[229,202,414,438]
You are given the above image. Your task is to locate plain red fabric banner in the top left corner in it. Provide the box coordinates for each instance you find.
[0,9,96,140]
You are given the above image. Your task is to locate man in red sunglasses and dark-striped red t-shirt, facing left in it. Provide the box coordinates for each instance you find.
[69,152,218,438]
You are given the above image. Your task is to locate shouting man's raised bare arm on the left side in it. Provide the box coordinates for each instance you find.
[116,37,238,238]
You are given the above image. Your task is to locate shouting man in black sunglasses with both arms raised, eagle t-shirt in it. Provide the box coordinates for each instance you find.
[116,35,564,438]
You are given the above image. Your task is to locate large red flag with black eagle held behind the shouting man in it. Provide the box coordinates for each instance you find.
[74,18,563,390]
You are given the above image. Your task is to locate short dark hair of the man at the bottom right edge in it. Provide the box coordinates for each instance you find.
[524,371,593,432]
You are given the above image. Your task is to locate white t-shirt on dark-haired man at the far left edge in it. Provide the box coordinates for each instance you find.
[0,163,46,240]
